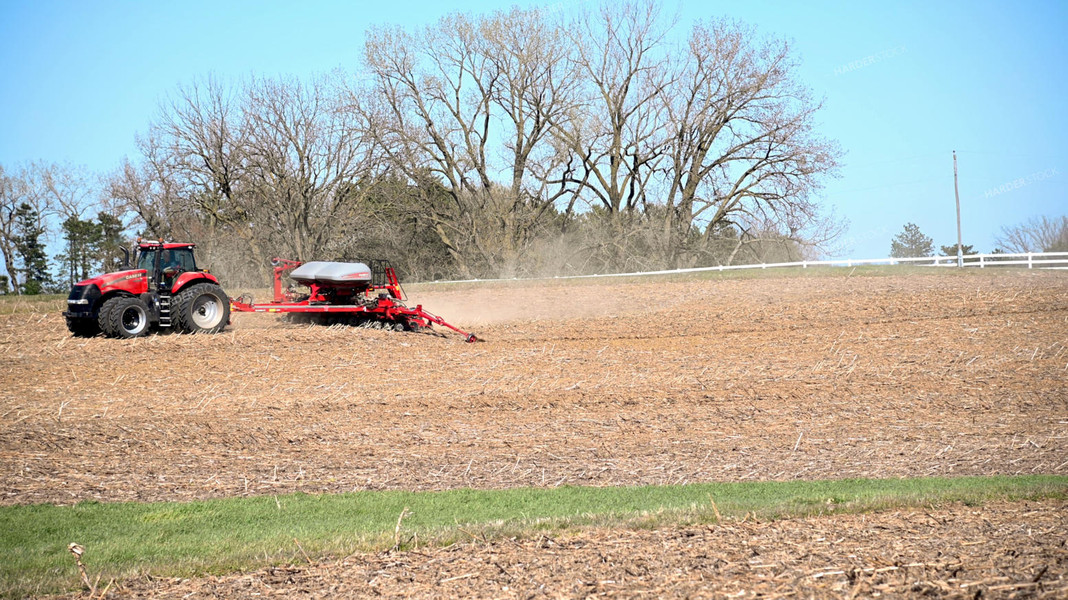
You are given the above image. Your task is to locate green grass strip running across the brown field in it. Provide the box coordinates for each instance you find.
[0,475,1068,597]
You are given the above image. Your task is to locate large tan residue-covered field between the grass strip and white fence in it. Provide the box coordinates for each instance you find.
[0,270,1068,503]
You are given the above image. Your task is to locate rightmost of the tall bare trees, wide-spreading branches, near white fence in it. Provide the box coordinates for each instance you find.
[661,21,838,267]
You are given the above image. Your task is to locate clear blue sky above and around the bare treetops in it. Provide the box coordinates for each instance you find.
[0,0,1068,258]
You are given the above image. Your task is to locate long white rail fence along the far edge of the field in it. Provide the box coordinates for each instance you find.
[425,252,1068,283]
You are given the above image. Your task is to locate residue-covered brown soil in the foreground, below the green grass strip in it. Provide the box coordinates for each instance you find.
[66,501,1068,600]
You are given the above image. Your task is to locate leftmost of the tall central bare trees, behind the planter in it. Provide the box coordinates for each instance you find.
[363,15,496,275]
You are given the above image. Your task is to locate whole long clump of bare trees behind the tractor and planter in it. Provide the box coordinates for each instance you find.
[109,0,837,277]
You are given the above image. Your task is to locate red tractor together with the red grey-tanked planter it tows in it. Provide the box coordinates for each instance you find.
[63,241,478,342]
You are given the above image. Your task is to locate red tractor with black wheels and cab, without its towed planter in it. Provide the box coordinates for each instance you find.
[63,240,230,337]
